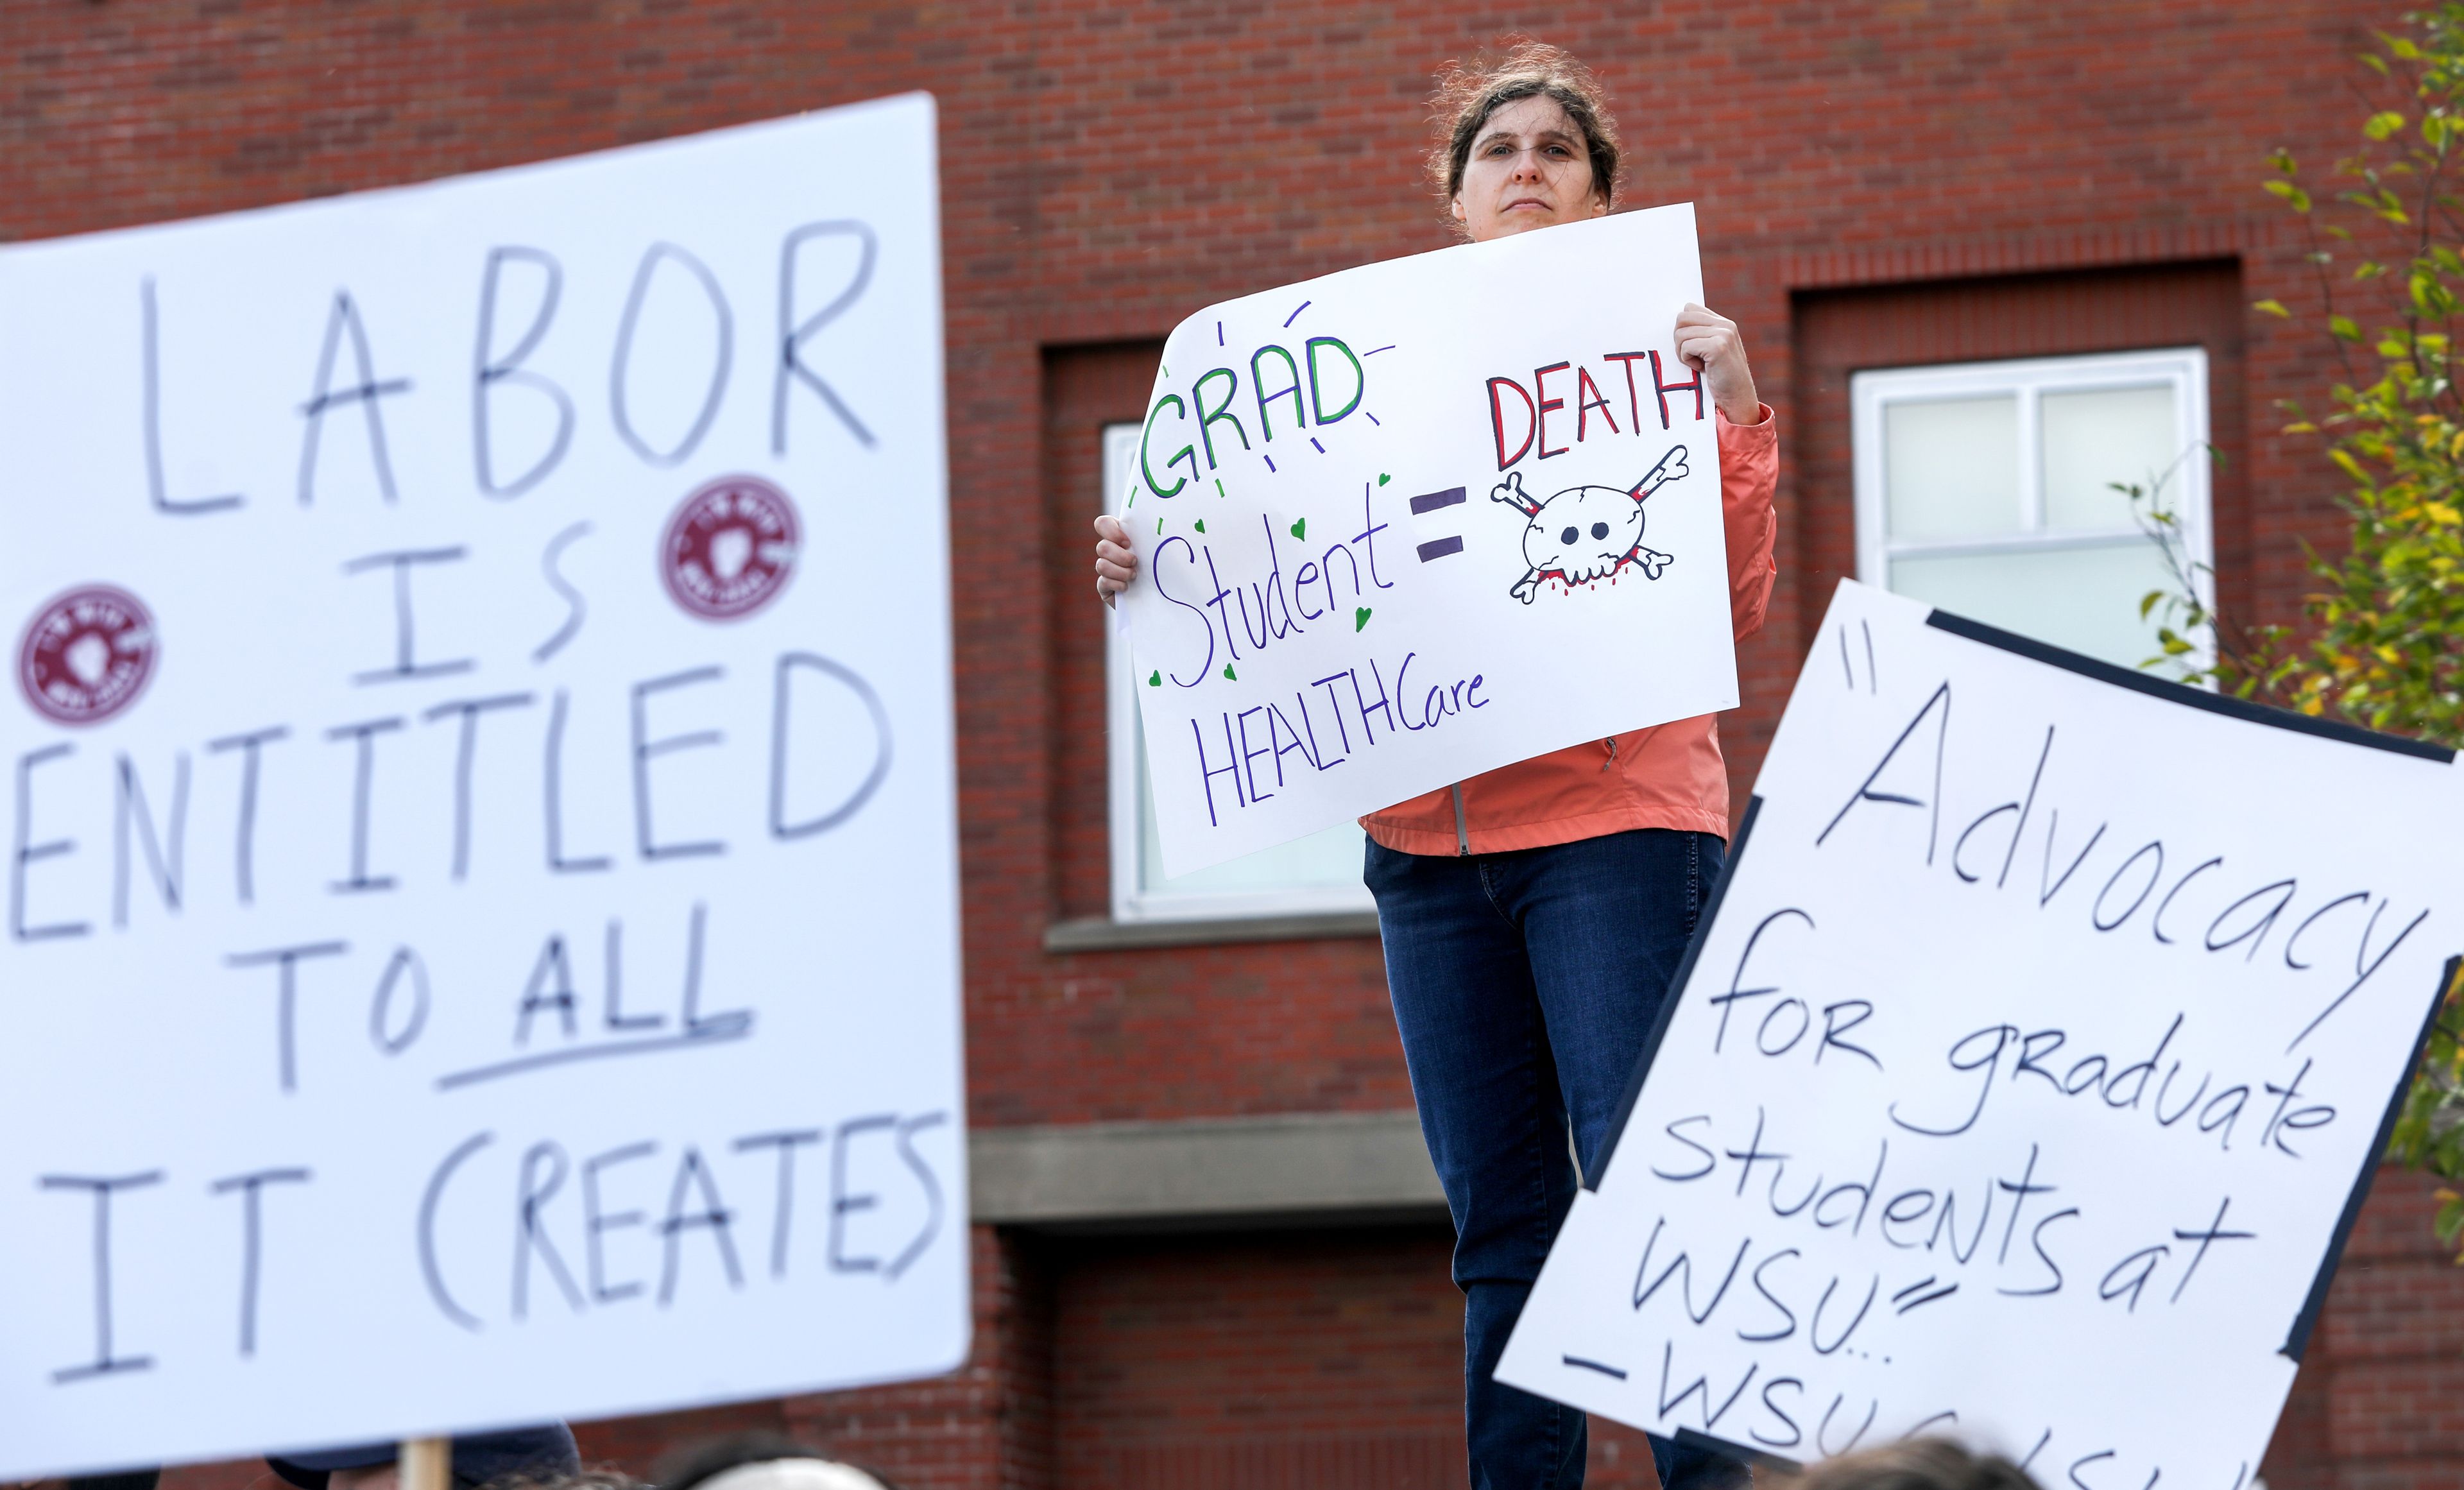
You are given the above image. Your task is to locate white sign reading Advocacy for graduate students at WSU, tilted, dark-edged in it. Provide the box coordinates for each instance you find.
[1498,584,2464,1490]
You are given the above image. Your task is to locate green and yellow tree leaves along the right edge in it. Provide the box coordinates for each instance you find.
[2207,0,2464,1261]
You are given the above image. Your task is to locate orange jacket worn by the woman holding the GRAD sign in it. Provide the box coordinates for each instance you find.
[1360,404,1779,855]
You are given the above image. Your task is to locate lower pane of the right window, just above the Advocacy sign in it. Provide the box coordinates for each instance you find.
[1890,540,2171,667]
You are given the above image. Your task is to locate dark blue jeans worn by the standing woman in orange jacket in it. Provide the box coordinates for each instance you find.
[1367,828,1749,1490]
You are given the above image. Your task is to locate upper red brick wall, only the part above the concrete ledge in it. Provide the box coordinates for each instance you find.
[0,0,2388,1167]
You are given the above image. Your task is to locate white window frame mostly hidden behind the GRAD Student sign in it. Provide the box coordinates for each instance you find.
[1097,424,1378,921]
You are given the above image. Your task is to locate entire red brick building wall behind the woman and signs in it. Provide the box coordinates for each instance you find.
[19,0,2464,1490]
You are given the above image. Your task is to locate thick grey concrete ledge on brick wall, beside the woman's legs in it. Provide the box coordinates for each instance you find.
[968,1111,1446,1229]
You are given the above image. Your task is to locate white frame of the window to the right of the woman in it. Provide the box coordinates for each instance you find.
[1848,347,2215,665]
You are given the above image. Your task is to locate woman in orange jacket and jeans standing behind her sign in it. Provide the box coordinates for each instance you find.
[1097,44,1779,1490]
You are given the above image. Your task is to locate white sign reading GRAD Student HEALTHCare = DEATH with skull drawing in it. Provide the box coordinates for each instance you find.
[1111,207,1737,874]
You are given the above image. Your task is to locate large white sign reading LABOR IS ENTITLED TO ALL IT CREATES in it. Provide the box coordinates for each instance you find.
[0,96,968,1480]
